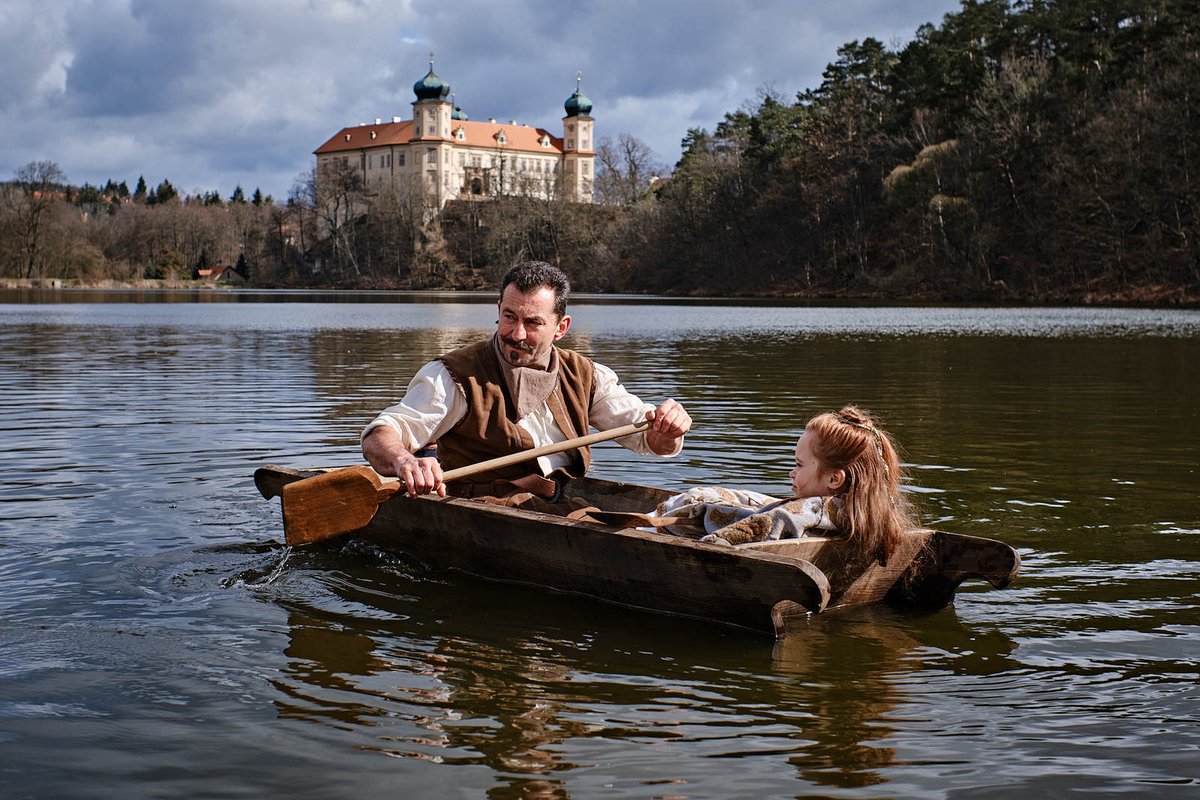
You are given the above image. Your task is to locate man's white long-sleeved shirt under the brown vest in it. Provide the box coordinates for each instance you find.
[362,361,683,475]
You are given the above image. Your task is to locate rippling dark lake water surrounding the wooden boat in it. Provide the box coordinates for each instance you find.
[0,291,1200,798]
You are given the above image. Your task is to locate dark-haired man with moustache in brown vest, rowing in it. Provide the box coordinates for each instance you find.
[362,261,691,503]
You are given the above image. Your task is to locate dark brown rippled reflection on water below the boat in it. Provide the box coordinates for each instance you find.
[276,543,1013,798]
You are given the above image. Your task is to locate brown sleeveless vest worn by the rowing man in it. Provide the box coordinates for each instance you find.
[438,339,594,497]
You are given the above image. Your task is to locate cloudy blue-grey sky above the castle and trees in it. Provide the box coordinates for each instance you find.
[0,0,959,199]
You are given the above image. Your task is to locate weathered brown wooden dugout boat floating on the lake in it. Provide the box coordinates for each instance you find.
[254,465,1020,636]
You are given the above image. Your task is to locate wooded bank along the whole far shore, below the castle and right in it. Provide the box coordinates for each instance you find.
[0,0,1200,306]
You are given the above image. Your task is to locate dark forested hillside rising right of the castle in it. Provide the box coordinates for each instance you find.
[628,0,1200,300]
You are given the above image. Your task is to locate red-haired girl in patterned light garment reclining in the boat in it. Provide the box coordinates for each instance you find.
[655,405,916,564]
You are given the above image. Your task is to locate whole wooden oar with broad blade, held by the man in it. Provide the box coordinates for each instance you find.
[281,420,650,545]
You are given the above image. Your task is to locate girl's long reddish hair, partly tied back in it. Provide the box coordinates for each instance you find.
[804,405,917,564]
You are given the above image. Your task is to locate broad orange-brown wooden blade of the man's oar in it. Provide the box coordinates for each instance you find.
[282,467,392,545]
